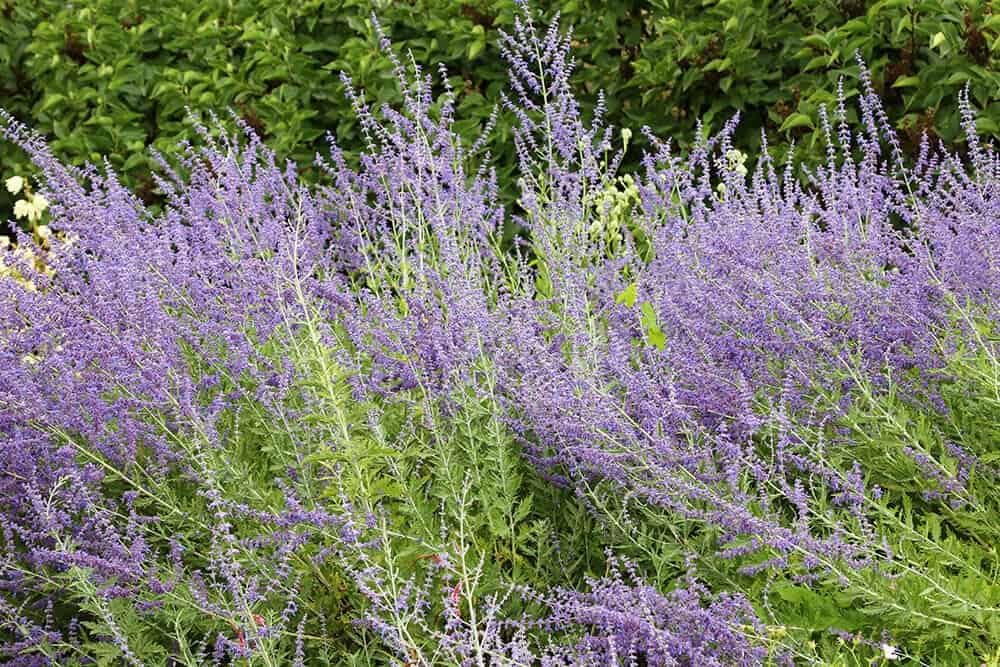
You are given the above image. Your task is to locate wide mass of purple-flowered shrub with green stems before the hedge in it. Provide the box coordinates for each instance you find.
[0,5,1000,666]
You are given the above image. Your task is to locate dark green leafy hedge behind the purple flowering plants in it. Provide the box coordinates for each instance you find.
[0,0,1000,215]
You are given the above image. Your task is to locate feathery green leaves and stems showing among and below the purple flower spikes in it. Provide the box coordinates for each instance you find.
[13,193,1000,667]
